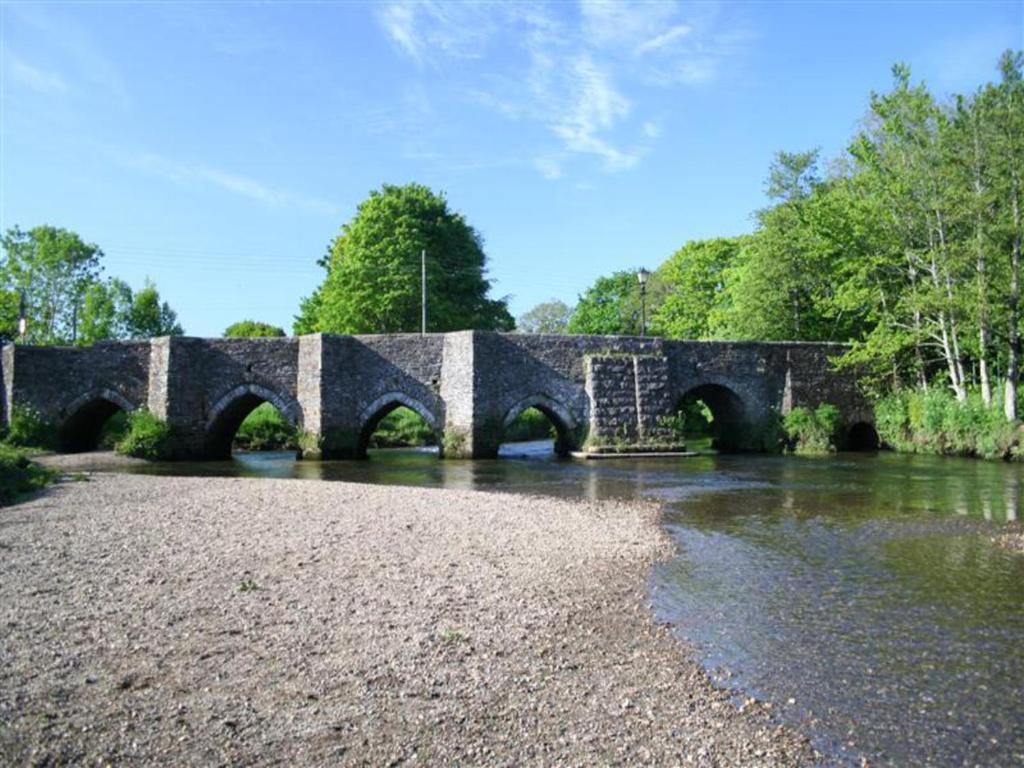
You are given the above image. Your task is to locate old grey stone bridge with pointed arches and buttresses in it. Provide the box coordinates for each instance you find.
[0,331,873,459]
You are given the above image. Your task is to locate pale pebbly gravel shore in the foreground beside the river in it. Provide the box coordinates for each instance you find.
[0,475,811,766]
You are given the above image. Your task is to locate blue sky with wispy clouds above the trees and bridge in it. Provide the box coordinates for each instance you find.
[0,0,1024,336]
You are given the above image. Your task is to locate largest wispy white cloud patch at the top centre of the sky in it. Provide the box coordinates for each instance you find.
[378,0,745,178]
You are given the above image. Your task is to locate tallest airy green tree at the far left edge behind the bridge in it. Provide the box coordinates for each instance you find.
[0,225,103,344]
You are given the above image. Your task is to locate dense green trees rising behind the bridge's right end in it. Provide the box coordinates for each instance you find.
[569,51,1024,430]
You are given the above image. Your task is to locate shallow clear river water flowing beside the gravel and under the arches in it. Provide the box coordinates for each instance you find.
[114,442,1024,766]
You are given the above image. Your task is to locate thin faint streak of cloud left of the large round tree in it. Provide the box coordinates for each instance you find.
[111,151,340,216]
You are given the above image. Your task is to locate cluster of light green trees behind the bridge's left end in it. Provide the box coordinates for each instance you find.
[0,225,183,345]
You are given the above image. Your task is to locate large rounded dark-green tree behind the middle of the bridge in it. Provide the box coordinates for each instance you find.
[294,184,514,334]
